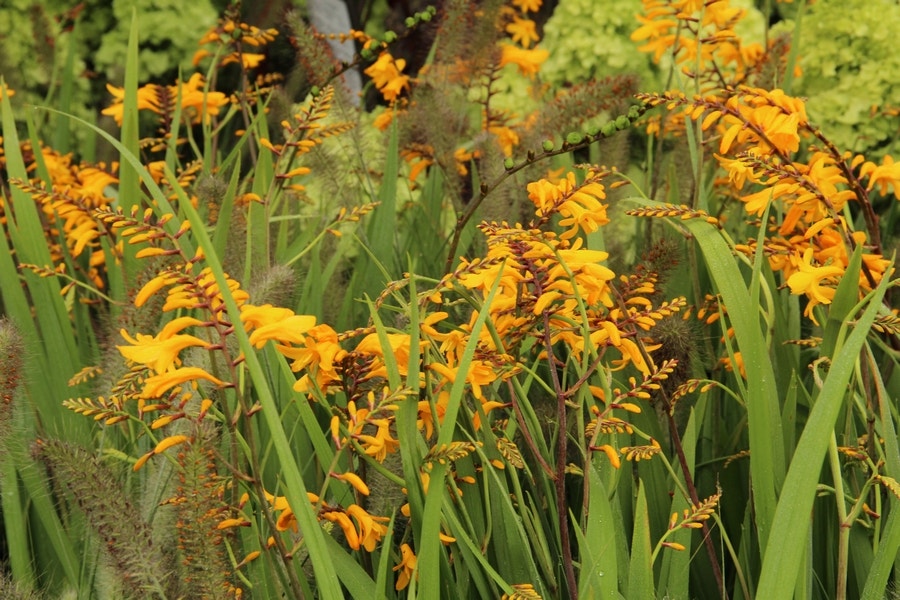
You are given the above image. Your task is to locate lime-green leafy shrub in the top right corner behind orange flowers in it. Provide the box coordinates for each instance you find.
[796,0,900,158]
